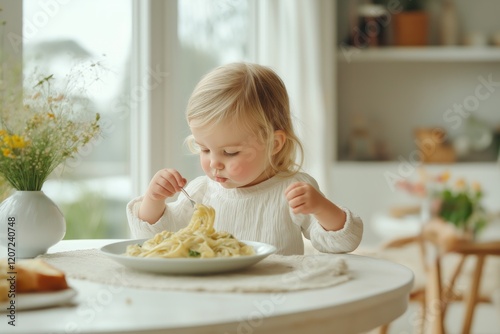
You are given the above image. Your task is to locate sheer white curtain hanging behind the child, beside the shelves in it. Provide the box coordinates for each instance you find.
[253,0,336,196]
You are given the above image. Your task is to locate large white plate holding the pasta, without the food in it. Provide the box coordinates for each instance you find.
[101,239,276,274]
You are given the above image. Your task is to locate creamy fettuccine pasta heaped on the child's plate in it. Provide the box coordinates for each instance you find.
[126,204,255,258]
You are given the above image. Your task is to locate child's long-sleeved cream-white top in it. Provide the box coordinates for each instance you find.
[127,173,363,255]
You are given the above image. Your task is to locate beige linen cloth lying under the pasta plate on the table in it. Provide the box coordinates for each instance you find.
[40,249,350,292]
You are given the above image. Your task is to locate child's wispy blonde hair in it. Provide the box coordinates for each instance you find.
[186,63,303,175]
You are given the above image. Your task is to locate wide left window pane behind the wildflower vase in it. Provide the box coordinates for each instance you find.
[23,0,132,239]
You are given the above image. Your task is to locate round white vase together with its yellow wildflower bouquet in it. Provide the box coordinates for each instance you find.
[0,68,100,258]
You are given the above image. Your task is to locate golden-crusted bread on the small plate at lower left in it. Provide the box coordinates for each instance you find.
[0,259,68,301]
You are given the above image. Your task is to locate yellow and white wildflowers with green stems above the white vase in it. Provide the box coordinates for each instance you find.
[0,71,100,191]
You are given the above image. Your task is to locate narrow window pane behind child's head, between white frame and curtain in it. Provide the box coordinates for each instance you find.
[177,0,249,180]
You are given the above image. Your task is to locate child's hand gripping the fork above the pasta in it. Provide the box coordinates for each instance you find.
[145,168,187,201]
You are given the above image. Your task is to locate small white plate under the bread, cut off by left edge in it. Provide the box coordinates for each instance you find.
[0,288,77,313]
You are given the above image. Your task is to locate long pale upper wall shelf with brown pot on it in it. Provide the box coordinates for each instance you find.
[337,46,500,63]
